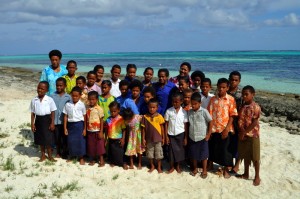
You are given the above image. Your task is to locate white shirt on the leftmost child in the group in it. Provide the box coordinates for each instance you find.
[30,95,57,116]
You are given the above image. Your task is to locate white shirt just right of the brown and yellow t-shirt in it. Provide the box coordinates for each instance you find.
[165,107,188,135]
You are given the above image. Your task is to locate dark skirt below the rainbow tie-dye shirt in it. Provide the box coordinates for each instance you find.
[108,139,124,166]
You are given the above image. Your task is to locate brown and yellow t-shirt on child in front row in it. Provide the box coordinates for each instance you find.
[141,113,165,142]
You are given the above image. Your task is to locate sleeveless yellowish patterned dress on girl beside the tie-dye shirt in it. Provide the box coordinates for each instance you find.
[125,115,145,156]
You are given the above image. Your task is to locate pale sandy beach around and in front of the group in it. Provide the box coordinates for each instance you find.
[0,66,300,199]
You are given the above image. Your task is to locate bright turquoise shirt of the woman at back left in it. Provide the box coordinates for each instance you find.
[40,65,68,96]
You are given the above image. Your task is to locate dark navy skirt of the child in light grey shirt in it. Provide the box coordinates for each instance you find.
[188,139,209,161]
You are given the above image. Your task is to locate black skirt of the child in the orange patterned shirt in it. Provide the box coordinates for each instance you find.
[208,132,233,167]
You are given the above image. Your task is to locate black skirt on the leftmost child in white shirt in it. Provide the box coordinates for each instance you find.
[33,115,55,146]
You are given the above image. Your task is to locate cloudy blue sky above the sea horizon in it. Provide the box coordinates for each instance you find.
[0,0,300,55]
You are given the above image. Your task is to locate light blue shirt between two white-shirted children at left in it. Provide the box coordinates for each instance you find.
[51,92,71,125]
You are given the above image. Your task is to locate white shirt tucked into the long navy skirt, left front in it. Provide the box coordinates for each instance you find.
[63,100,86,122]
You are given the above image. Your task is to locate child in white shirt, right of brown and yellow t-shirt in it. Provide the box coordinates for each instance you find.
[165,92,188,174]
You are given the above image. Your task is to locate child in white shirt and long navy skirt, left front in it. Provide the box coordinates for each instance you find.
[63,86,86,165]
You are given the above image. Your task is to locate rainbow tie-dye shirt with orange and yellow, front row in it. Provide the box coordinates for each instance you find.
[105,115,126,139]
